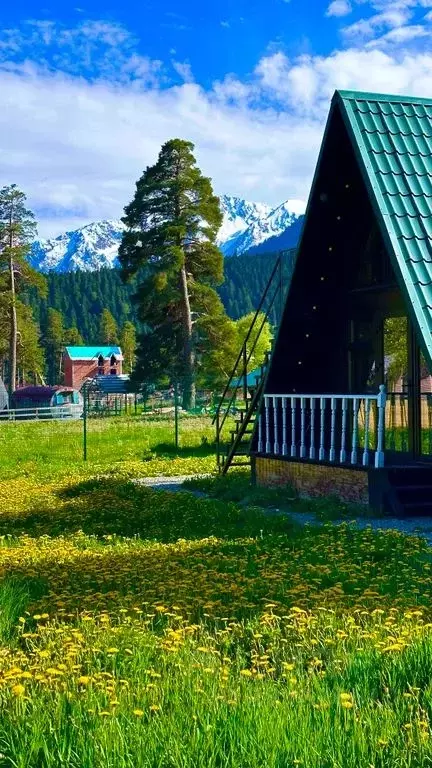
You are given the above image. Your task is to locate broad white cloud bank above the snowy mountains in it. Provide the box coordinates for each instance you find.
[0,18,432,236]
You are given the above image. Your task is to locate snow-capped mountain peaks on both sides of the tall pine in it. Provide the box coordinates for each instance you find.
[29,195,305,272]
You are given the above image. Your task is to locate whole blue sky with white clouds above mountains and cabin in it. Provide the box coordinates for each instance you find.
[0,0,432,236]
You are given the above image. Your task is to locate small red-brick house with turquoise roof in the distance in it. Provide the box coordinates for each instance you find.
[63,345,123,390]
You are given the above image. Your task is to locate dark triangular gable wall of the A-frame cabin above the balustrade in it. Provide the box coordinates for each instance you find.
[265,104,400,394]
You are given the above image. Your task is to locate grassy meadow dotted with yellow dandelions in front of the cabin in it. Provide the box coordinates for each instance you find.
[0,419,432,768]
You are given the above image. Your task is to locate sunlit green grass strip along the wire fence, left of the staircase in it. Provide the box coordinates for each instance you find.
[0,416,215,478]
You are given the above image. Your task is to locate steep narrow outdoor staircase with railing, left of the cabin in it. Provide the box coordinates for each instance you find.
[213,254,283,475]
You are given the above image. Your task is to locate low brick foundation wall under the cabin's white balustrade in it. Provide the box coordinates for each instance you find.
[255,457,369,504]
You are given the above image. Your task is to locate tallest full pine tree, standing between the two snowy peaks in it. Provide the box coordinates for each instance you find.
[119,139,223,409]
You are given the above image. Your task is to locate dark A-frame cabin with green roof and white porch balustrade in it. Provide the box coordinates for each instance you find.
[252,91,432,514]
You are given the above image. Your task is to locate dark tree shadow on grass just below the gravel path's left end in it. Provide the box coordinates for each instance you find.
[0,477,298,543]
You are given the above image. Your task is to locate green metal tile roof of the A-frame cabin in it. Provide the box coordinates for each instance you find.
[333,91,432,363]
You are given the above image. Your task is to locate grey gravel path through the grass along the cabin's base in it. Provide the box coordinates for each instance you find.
[134,475,432,546]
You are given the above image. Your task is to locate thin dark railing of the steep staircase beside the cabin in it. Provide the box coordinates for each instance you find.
[212,255,282,466]
